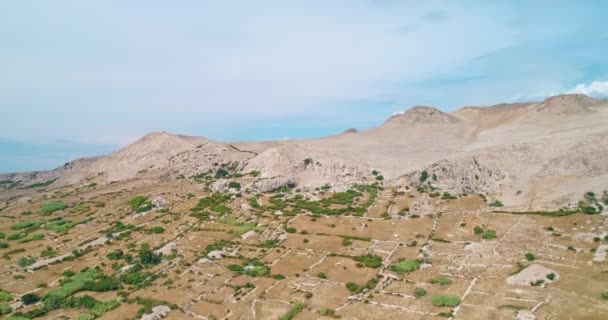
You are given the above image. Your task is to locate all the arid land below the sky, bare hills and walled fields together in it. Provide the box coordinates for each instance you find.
[0,95,608,320]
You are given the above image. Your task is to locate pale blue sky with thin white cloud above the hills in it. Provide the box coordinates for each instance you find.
[0,0,608,173]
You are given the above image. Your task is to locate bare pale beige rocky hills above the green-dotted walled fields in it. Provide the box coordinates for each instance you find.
[0,95,608,210]
